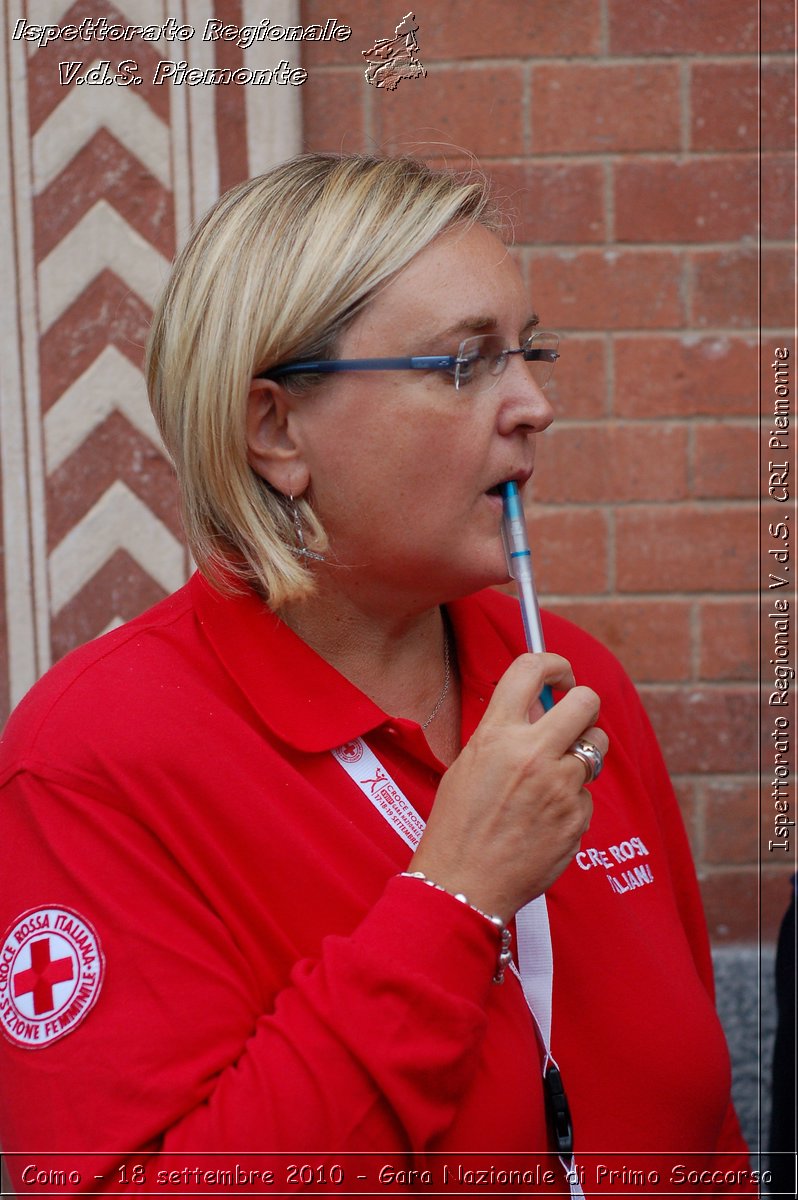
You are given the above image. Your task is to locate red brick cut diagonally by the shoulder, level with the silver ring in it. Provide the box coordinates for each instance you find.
[642,686,757,775]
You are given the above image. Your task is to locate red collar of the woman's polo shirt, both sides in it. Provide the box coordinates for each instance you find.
[190,574,515,752]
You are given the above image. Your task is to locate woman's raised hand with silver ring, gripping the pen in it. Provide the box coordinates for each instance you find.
[408,654,608,920]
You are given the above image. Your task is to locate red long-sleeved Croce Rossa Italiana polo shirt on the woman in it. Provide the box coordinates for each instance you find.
[0,576,746,1195]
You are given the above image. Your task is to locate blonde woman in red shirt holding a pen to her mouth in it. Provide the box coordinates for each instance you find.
[0,156,748,1194]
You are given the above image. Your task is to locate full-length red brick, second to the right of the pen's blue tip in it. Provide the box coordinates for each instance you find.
[616,504,758,593]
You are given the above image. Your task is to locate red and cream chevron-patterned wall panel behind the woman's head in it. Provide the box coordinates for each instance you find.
[0,0,302,724]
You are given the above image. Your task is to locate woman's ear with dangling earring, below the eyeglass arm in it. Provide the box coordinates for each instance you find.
[246,379,311,496]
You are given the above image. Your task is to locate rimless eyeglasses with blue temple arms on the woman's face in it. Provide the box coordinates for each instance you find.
[257,330,559,392]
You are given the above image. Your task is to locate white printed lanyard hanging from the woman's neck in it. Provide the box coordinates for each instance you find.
[331,738,584,1200]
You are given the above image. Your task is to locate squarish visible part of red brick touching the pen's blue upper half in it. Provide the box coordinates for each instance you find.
[527,503,608,598]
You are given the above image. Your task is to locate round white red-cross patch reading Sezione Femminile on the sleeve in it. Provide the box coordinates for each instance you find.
[0,905,106,1049]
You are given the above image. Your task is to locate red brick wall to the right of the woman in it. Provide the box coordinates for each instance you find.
[301,0,794,942]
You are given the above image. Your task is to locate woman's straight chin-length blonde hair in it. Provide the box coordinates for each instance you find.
[146,155,502,610]
